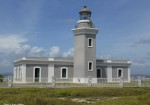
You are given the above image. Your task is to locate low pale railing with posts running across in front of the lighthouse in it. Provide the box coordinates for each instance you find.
[0,77,150,88]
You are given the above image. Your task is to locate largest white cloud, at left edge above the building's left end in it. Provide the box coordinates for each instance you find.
[0,35,46,58]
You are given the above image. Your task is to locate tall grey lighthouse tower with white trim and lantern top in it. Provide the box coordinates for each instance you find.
[72,6,98,83]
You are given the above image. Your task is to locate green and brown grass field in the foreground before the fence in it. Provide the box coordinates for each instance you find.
[0,88,150,105]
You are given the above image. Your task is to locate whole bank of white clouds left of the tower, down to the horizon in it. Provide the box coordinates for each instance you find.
[0,35,74,72]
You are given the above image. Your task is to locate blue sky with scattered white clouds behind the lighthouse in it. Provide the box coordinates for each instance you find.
[0,0,150,74]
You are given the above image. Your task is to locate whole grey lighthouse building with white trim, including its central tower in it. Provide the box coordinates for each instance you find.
[14,6,131,83]
